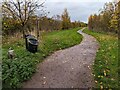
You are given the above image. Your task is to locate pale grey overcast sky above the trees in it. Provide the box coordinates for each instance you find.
[38,0,113,22]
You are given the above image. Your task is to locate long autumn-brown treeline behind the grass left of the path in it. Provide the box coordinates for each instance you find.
[2,9,87,35]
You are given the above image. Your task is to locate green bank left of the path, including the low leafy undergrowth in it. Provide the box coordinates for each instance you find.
[2,28,82,88]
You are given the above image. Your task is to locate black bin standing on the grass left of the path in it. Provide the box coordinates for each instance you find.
[25,35,38,53]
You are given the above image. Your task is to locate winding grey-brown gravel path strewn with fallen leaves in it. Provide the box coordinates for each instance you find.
[23,29,99,88]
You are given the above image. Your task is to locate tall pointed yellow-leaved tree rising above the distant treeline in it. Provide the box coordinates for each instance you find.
[62,8,71,29]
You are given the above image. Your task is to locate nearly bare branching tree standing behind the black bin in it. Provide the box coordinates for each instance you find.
[2,0,45,37]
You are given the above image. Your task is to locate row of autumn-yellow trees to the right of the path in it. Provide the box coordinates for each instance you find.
[88,1,120,33]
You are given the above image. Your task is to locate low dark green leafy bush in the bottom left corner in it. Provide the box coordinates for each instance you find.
[2,58,35,88]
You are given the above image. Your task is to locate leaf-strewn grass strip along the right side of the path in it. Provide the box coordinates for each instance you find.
[84,29,120,88]
